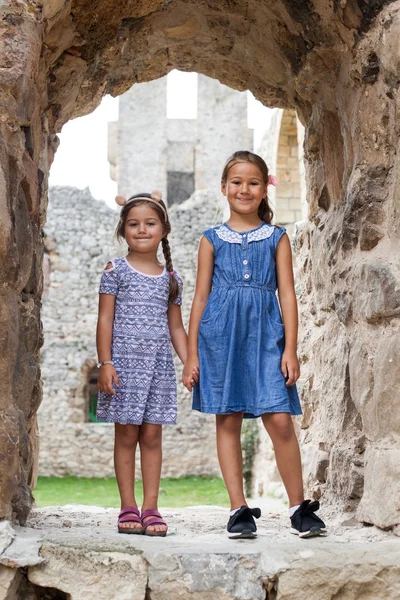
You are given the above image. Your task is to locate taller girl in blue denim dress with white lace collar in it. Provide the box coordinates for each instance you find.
[182,151,326,538]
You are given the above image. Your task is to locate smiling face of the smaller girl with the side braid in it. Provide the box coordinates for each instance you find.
[124,203,164,253]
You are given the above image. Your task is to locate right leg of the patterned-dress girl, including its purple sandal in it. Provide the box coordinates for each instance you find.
[139,423,167,531]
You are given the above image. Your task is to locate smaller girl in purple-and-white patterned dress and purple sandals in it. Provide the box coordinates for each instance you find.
[97,192,194,536]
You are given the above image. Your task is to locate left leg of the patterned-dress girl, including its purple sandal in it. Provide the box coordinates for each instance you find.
[114,423,141,528]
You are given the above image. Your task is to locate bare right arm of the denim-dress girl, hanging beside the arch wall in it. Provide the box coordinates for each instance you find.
[276,235,300,386]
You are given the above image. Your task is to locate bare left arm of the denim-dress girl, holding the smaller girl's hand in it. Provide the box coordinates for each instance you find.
[182,236,214,391]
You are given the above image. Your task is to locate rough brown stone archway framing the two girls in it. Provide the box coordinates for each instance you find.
[0,0,400,527]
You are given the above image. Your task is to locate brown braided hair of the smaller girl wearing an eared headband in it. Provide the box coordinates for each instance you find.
[115,193,179,304]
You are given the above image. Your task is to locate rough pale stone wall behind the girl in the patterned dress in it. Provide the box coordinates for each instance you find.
[38,187,219,477]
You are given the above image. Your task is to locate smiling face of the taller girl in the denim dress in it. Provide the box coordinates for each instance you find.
[221,162,268,215]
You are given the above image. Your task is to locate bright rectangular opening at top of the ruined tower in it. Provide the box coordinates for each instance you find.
[167,69,198,119]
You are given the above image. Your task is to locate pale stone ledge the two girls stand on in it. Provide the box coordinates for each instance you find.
[0,506,400,600]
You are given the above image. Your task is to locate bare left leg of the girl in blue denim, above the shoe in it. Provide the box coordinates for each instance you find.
[216,412,247,510]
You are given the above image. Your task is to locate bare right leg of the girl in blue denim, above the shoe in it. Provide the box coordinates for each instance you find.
[262,413,304,507]
